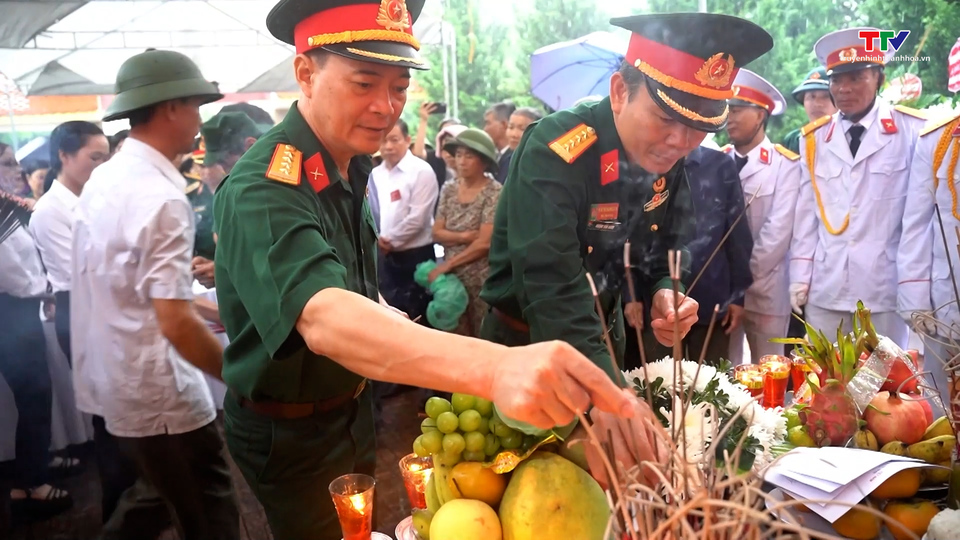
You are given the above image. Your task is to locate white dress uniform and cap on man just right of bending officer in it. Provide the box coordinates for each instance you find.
[723,69,800,363]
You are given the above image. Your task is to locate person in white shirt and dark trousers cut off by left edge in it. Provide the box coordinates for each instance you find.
[0,227,73,517]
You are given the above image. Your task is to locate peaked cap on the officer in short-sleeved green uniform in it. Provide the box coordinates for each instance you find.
[267,0,427,69]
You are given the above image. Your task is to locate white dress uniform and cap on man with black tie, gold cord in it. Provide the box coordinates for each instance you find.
[790,28,925,347]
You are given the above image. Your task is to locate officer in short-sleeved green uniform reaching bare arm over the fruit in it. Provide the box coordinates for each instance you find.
[215,0,638,540]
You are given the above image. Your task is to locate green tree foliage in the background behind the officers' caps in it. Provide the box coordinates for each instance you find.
[407,0,960,141]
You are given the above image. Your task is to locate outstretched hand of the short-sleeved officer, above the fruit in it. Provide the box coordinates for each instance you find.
[490,341,636,429]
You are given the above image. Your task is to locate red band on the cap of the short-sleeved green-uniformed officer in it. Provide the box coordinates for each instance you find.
[293,0,420,54]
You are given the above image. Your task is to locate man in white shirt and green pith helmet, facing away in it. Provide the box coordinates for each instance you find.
[71,50,239,540]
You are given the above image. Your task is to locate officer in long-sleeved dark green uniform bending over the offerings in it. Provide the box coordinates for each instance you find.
[481,13,773,472]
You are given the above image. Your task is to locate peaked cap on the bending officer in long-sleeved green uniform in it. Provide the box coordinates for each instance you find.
[610,13,773,133]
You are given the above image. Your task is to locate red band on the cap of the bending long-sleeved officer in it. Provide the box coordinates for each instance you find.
[626,34,739,100]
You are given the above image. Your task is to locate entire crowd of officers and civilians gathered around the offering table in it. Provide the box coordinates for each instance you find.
[0,0,960,540]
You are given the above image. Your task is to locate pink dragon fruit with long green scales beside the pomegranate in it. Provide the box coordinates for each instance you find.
[777,303,878,447]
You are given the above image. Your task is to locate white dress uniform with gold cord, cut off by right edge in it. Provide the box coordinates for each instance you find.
[897,110,960,410]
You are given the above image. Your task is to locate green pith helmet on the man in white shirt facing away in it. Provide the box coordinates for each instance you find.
[103,50,223,122]
